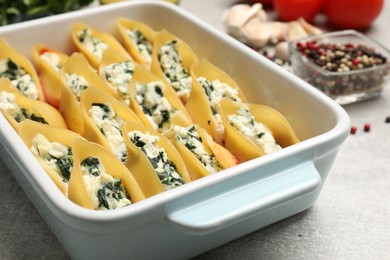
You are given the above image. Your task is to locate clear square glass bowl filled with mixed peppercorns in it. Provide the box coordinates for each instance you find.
[291,38,390,101]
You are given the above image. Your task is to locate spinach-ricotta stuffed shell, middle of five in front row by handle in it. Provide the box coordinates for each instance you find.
[123,121,191,197]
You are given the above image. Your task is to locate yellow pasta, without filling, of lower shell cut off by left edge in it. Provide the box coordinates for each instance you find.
[0,78,66,131]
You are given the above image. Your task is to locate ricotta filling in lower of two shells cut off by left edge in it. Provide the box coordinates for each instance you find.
[0,91,47,124]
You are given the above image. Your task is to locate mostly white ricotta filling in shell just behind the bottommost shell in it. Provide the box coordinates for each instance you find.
[88,103,127,163]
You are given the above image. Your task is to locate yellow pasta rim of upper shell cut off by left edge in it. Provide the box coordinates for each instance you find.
[0,38,45,101]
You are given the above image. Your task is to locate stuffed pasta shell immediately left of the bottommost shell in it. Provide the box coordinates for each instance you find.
[18,120,80,196]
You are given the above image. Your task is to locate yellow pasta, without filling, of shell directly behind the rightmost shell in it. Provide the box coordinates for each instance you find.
[185,59,246,144]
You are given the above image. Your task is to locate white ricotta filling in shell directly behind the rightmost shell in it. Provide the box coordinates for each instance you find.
[197,77,241,137]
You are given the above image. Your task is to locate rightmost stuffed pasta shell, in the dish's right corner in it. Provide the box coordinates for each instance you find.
[221,98,299,162]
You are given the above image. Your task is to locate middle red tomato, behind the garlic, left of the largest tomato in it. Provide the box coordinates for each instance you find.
[274,0,327,22]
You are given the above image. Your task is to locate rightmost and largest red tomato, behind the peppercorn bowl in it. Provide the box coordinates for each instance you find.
[324,0,384,30]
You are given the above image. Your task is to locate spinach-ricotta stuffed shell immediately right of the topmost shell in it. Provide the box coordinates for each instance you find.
[151,30,197,104]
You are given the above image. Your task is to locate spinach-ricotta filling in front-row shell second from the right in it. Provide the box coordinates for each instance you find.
[172,125,222,174]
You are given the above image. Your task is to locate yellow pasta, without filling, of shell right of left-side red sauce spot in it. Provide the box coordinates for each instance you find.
[60,52,117,134]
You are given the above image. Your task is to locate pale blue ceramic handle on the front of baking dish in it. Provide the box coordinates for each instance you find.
[167,161,321,234]
